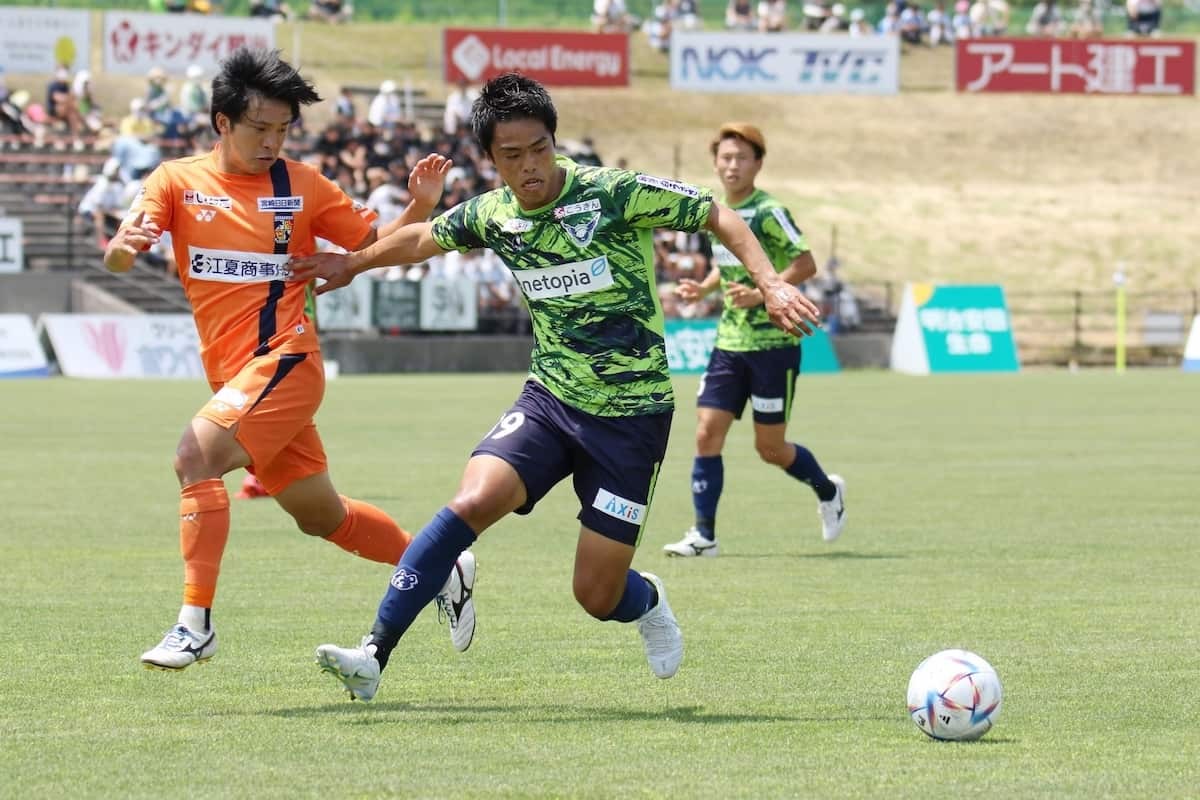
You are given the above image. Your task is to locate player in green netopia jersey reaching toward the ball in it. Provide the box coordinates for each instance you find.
[292,73,818,700]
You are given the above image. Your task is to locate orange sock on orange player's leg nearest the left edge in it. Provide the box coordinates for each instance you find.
[179,477,229,608]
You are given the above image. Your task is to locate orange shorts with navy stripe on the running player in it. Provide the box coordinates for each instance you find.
[196,353,328,495]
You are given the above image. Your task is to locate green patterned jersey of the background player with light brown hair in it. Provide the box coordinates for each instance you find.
[713,190,809,353]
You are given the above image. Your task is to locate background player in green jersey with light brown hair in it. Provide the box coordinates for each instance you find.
[662,122,846,557]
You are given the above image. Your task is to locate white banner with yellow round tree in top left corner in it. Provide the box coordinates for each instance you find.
[0,6,91,76]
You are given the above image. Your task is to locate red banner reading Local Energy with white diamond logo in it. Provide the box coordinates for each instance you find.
[443,28,629,86]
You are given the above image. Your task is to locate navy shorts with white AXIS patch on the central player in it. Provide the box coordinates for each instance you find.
[472,380,673,547]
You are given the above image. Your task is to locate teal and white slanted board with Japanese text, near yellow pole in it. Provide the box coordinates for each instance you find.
[892,283,1020,375]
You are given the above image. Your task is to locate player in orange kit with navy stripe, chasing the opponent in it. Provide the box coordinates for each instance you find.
[104,49,475,669]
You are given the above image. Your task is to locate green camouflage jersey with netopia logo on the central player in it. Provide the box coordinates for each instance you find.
[433,156,713,416]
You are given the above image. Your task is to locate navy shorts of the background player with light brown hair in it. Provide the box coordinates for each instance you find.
[696,344,800,425]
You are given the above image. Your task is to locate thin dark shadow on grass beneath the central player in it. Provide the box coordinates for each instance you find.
[265,700,893,724]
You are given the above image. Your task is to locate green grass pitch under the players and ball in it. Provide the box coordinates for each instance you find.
[0,372,1200,799]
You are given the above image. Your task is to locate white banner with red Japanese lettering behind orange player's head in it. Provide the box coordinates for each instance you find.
[102,11,275,76]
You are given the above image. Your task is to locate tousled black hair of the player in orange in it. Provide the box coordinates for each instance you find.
[210,47,320,133]
